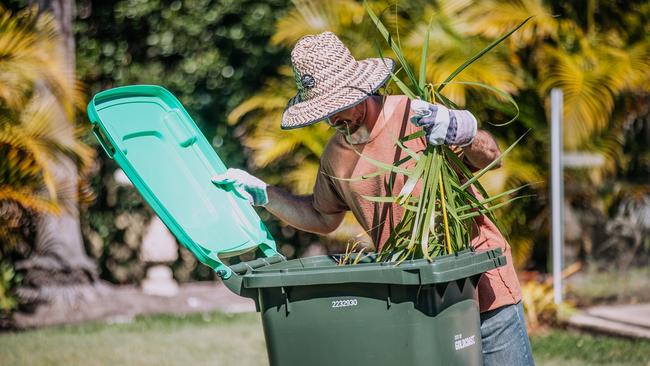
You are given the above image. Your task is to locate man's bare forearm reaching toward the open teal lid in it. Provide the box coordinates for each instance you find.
[264,186,345,234]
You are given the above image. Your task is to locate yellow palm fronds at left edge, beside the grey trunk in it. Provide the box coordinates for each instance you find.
[0,6,94,217]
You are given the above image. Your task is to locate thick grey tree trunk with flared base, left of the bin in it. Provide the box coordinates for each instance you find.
[16,0,98,304]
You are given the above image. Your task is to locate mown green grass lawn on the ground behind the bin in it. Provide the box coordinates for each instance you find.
[0,313,650,366]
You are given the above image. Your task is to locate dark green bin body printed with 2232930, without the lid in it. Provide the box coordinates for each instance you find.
[244,253,503,366]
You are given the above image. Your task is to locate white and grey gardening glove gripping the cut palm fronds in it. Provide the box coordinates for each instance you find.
[411,100,476,147]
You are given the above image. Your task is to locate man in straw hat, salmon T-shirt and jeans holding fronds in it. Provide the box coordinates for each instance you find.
[213,32,534,366]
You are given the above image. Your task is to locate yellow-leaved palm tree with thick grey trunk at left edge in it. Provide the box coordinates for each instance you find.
[0,1,97,310]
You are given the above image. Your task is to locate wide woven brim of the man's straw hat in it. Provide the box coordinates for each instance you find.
[281,58,395,130]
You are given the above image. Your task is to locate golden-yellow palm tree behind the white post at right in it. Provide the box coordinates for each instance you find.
[460,0,650,266]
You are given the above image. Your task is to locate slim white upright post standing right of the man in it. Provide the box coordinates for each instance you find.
[551,88,564,304]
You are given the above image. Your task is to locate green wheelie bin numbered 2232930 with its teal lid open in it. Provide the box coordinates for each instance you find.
[88,85,506,366]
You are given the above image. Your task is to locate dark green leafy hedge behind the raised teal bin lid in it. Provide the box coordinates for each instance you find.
[75,0,288,283]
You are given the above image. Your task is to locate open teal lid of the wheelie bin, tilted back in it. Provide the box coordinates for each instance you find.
[88,85,277,278]
